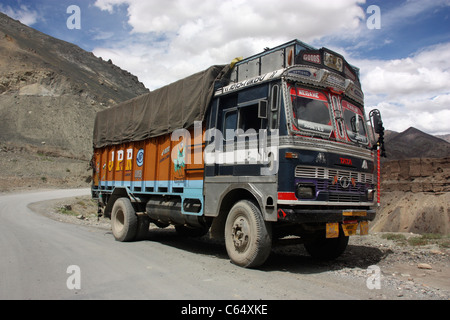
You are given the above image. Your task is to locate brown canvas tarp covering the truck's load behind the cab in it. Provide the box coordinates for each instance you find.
[93,66,228,148]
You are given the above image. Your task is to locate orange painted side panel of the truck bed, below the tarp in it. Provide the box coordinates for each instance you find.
[93,122,205,191]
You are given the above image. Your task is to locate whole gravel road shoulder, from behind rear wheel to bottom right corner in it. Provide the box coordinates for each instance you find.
[31,197,450,300]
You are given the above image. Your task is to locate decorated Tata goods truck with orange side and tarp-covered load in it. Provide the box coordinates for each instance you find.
[91,40,384,268]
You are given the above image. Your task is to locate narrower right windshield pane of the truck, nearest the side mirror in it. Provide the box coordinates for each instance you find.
[342,100,369,144]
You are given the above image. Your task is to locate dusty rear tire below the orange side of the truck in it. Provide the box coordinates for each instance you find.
[111,198,138,242]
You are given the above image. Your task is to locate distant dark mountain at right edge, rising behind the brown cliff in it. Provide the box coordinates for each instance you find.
[385,127,450,160]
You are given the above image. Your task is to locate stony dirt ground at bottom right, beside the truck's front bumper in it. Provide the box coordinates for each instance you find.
[337,232,450,300]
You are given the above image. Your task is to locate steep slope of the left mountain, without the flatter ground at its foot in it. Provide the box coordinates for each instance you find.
[0,13,148,159]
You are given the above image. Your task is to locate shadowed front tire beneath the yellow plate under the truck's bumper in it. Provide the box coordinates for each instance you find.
[304,229,349,261]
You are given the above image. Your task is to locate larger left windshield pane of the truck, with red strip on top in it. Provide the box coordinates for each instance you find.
[290,86,333,134]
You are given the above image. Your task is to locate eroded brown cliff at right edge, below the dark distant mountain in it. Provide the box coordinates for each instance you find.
[371,157,450,235]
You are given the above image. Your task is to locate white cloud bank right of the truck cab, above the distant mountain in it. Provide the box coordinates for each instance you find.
[358,43,450,134]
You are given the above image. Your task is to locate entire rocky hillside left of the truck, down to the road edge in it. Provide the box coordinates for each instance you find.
[0,13,148,192]
